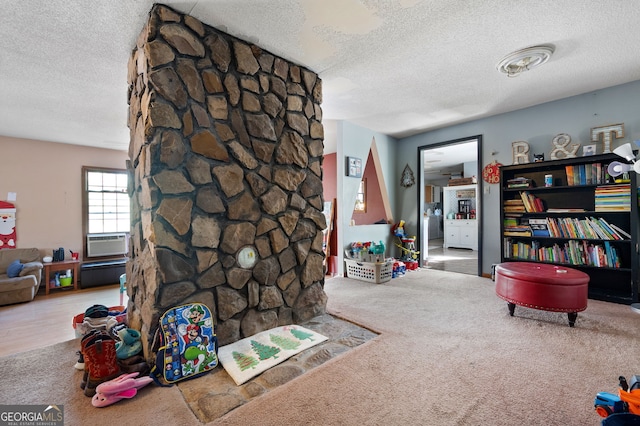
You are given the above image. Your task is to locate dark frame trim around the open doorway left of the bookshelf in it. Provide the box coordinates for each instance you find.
[416,135,484,277]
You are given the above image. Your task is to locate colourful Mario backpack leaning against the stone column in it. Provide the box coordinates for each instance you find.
[150,303,218,386]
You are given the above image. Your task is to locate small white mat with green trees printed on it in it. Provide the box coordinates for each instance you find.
[218,325,327,386]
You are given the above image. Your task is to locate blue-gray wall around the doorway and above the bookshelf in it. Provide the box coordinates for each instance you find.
[396,81,640,274]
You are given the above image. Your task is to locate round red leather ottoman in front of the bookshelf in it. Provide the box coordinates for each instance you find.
[495,262,589,327]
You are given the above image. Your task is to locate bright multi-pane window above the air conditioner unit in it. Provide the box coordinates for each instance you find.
[82,167,131,234]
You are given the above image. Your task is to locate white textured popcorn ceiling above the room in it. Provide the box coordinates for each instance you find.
[0,0,640,152]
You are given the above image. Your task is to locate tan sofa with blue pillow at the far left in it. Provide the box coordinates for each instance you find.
[0,248,43,306]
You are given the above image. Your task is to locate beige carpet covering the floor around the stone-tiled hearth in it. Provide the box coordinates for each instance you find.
[0,270,640,426]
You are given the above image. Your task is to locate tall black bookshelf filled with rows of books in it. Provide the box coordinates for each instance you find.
[500,154,639,304]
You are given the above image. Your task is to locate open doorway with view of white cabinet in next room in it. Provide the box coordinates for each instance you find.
[417,135,483,276]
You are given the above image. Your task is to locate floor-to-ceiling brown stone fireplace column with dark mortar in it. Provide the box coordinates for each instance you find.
[127,5,327,357]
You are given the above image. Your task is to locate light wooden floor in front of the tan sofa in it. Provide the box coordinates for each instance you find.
[0,284,128,356]
